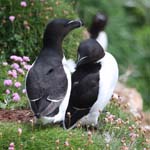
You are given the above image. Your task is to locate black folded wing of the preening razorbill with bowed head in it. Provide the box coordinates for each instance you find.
[64,67,99,129]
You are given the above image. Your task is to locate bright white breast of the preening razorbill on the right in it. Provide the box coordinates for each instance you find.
[91,52,118,111]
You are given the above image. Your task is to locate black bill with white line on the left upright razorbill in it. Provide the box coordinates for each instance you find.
[66,20,84,29]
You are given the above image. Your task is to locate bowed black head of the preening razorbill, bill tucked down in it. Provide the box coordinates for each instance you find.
[77,39,105,68]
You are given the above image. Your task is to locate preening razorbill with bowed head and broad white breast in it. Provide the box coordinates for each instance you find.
[63,39,118,129]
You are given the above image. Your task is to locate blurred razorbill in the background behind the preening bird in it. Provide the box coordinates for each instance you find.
[88,12,108,50]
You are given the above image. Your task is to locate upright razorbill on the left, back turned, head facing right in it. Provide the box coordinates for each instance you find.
[26,19,82,124]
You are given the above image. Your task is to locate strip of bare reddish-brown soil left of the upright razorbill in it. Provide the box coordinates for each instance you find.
[0,109,33,122]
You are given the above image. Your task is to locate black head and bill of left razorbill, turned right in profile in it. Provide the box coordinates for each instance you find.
[43,19,83,46]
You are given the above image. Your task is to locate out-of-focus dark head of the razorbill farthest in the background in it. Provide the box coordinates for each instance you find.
[89,13,108,38]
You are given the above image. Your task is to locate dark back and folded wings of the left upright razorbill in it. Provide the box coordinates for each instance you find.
[26,64,67,116]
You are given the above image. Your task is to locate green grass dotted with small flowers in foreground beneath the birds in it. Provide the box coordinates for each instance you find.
[0,101,148,150]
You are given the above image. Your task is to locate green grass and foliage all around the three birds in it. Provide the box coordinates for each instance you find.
[0,0,150,150]
